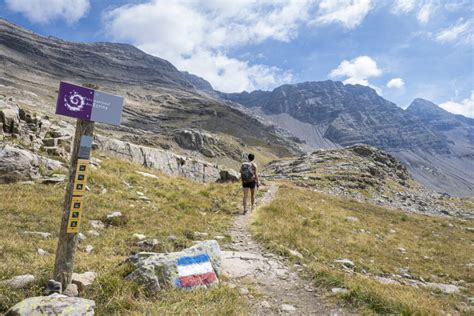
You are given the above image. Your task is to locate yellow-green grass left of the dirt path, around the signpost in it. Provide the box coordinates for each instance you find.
[0,154,246,315]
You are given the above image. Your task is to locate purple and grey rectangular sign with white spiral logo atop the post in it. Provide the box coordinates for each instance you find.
[56,81,123,125]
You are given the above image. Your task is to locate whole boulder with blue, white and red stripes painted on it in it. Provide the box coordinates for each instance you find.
[127,240,221,291]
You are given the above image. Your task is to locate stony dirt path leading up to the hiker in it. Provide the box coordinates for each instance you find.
[222,184,346,315]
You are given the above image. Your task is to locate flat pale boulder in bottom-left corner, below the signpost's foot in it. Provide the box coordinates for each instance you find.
[7,294,95,316]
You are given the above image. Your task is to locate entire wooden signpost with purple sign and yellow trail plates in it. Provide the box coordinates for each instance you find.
[53,82,124,289]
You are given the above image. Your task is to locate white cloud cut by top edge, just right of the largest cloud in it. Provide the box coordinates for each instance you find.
[313,0,373,29]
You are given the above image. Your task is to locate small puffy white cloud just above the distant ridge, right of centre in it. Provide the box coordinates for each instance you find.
[329,56,382,88]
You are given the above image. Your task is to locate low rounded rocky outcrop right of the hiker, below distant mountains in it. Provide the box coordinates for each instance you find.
[264,145,472,218]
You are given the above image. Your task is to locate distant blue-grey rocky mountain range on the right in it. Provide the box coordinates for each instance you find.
[220,80,474,196]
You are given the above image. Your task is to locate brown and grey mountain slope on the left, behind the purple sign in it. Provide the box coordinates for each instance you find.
[0,19,298,166]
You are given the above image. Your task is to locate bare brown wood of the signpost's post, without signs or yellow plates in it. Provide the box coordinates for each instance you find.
[53,119,94,290]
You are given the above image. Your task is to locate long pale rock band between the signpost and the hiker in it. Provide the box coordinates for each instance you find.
[95,136,235,182]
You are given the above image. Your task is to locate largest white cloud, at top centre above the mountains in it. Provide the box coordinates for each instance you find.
[104,0,313,92]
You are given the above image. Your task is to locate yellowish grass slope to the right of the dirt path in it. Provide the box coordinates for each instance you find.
[252,184,474,315]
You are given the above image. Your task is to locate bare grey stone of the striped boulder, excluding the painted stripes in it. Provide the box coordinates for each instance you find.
[126,240,221,291]
